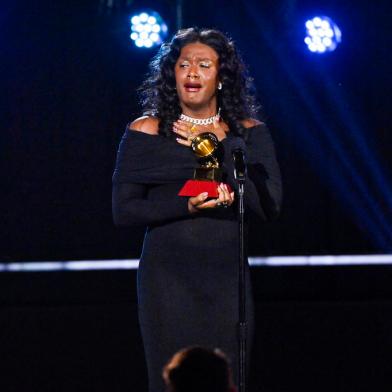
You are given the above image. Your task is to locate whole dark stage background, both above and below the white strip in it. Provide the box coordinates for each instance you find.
[0,0,392,392]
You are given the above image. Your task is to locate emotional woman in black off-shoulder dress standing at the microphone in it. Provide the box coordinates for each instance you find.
[113,28,281,392]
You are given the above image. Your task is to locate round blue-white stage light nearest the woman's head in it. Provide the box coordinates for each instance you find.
[129,11,167,48]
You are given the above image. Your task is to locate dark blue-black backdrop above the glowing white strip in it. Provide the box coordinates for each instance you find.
[0,0,392,261]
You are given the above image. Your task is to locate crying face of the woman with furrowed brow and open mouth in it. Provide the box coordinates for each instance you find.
[175,42,219,115]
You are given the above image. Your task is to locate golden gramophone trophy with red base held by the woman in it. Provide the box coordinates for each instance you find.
[178,132,231,198]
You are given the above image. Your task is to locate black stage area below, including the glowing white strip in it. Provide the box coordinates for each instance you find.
[0,256,392,392]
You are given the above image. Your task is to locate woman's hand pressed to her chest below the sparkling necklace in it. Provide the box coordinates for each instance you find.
[173,118,226,147]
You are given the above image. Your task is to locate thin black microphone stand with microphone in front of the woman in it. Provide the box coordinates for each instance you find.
[233,150,247,392]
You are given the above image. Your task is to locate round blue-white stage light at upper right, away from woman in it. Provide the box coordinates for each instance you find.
[304,16,342,53]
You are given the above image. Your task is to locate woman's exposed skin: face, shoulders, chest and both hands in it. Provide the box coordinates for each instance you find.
[129,42,256,213]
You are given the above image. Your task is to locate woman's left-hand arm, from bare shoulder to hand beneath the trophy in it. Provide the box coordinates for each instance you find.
[112,117,220,226]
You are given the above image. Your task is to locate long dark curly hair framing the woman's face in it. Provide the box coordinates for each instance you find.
[139,27,258,136]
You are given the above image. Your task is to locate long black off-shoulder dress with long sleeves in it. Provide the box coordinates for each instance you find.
[113,124,281,392]
